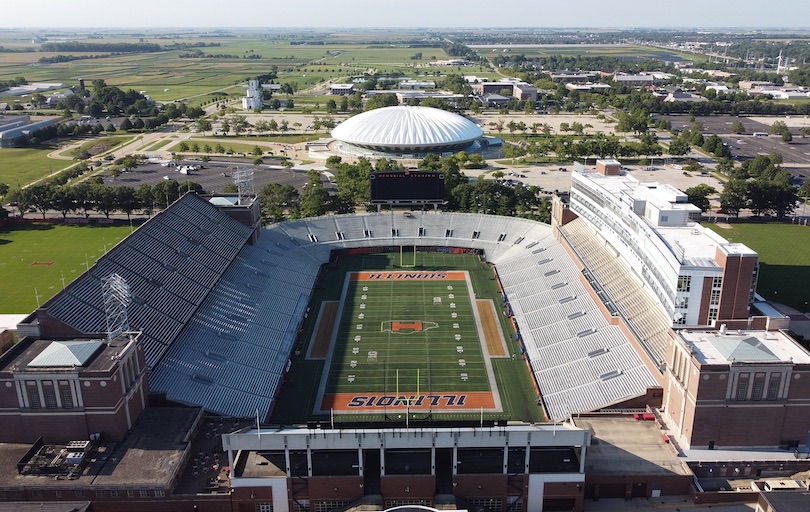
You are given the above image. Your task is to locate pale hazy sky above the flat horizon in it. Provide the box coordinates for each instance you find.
[0,0,810,29]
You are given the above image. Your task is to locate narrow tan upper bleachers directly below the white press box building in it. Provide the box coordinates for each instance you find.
[561,219,672,364]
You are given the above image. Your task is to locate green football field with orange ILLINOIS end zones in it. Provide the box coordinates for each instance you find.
[310,270,506,414]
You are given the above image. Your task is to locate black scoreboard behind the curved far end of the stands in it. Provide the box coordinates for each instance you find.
[369,171,444,205]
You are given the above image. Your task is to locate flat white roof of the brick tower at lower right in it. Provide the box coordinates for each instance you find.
[678,330,810,365]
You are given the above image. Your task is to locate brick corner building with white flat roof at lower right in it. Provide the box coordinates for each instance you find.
[663,328,810,449]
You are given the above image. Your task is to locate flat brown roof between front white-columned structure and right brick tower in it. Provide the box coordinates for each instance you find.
[575,416,691,475]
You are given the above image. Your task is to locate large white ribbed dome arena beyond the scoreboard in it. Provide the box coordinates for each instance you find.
[332,106,484,153]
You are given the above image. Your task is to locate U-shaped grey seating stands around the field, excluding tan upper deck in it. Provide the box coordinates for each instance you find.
[21,194,657,421]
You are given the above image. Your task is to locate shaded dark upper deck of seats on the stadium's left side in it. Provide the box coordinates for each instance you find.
[43,194,250,368]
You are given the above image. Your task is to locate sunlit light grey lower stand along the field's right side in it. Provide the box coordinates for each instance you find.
[495,245,656,420]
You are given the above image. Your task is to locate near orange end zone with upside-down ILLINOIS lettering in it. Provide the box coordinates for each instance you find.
[321,391,495,413]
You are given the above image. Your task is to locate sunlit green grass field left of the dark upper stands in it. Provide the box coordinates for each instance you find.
[0,223,137,314]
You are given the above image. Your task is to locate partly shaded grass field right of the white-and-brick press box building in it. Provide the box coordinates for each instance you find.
[707,222,810,311]
